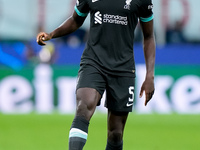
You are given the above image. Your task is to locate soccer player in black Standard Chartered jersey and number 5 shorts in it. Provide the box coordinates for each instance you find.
[37,0,155,150]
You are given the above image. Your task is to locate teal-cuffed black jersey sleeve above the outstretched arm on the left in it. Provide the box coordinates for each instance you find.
[74,0,89,17]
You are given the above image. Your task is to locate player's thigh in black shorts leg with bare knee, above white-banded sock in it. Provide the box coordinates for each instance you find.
[76,65,106,120]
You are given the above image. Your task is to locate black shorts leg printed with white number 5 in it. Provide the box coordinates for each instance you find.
[105,76,135,112]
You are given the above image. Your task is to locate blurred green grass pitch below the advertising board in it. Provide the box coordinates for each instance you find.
[0,113,200,150]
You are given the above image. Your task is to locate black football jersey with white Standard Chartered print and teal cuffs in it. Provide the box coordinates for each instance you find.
[75,0,153,76]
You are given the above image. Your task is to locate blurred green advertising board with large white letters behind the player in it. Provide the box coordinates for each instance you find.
[0,64,200,114]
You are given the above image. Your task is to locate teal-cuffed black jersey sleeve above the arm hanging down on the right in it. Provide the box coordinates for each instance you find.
[139,0,154,22]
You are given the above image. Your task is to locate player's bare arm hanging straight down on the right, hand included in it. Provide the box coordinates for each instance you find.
[140,20,155,106]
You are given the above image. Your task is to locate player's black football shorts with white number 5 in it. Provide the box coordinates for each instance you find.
[76,64,135,112]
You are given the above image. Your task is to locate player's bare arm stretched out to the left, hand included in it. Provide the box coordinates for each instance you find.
[37,11,86,45]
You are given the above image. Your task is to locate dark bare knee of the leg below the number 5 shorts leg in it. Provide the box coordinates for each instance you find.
[108,130,123,143]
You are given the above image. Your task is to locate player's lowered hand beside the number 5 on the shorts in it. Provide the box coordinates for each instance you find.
[140,77,155,106]
